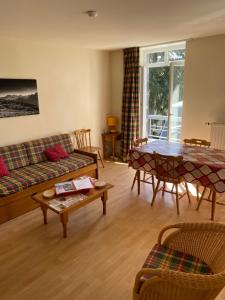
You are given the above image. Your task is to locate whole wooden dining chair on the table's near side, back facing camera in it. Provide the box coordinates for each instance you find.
[151,152,191,215]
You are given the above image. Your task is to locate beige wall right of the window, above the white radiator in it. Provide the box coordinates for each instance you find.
[182,35,225,139]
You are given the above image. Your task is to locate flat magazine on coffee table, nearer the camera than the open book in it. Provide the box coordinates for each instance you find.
[48,193,87,211]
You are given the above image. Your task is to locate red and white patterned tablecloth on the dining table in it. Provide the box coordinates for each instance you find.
[128,140,225,193]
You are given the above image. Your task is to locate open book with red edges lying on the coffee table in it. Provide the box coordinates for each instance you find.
[55,177,94,196]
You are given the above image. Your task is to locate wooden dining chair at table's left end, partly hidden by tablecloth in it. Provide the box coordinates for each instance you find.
[131,138,155,195]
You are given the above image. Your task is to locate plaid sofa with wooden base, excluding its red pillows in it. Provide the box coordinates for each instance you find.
[0,134,98,223]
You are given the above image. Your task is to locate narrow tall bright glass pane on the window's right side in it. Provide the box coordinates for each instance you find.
[170,66,184,142]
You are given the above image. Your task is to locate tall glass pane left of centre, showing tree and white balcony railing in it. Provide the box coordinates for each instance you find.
[147,67,169,139]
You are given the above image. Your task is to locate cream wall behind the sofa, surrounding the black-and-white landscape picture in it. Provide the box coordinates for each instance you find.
[0,39,111,146]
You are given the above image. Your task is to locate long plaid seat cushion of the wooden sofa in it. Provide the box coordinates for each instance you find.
[0,153,94,196]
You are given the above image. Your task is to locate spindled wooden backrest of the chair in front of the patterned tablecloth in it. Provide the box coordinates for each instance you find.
[153,152,183,183]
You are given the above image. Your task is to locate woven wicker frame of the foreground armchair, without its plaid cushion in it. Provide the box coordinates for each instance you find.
[133,223,225,300]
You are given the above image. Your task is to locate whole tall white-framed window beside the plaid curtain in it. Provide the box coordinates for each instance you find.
[141,43,185,141]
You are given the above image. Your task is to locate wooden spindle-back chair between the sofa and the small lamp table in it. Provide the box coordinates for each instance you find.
[74,129,104,168]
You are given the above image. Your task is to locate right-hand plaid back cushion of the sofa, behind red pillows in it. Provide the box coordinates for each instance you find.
[24,134,74,164]
